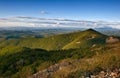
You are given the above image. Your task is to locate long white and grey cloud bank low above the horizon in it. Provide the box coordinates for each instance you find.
[0,16,120,29]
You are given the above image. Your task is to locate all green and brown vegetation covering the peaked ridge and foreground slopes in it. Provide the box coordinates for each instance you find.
[0,29,120,78]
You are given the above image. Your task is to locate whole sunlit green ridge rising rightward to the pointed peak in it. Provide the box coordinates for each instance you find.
[0,29,106,50]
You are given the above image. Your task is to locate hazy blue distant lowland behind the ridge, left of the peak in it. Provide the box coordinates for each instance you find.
[0,27,78,42]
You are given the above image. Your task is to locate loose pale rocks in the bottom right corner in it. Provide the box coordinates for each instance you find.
[80,68,120,78]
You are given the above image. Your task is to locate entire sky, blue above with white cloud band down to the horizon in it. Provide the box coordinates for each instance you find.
[0,0,120,29]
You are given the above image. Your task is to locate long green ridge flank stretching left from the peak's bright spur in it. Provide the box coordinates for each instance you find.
[0,31,81,50]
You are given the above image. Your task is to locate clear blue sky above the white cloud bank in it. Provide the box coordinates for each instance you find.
[0,0,120,21]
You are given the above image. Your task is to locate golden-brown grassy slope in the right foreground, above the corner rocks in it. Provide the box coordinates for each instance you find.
[52,42,120,78]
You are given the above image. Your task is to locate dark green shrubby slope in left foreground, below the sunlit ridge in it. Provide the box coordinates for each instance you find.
[0,46,95,78]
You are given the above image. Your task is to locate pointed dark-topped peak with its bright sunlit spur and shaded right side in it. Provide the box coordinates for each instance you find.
[63,29,107,49]
